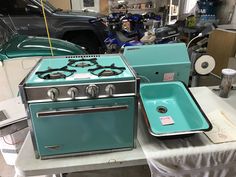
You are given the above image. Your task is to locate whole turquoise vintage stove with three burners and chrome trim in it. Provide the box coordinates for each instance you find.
[20,55,139,159]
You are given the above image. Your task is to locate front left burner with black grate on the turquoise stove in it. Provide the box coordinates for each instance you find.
[35,66,76,80]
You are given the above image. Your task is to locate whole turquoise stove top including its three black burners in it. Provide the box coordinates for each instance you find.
[26,55,134,86]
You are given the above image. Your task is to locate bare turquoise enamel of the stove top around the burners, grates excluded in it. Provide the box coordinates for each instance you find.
[26,55,134,86]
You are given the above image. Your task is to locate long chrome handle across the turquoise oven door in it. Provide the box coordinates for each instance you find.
[36,105,129,118]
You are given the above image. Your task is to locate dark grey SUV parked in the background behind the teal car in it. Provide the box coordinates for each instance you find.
[0,0,106,53]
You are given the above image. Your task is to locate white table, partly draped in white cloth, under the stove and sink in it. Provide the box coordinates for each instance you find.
[15,87,236,177]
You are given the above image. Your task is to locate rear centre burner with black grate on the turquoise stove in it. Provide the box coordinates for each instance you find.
[67,58,97,68]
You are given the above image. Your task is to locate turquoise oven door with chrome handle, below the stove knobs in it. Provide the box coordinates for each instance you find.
[29,97,136,158]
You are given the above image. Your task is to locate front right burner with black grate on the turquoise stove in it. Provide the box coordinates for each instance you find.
[88,63,125,77]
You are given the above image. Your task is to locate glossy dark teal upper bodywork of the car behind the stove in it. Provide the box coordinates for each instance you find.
[0,34,86,60]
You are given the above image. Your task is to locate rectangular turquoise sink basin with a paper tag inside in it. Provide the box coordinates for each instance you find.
[140,82,212,137]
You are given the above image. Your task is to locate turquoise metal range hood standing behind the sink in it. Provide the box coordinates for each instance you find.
[124,43,191,85]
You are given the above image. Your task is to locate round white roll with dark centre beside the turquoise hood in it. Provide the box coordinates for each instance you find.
[194,55,215,75]
